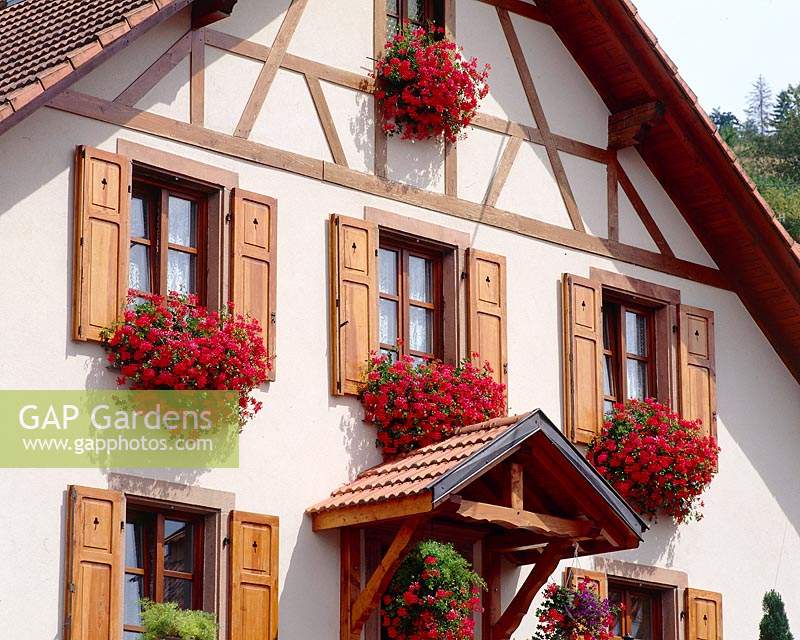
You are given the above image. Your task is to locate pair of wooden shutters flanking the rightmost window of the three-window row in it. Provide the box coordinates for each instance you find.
[562,274,717,443]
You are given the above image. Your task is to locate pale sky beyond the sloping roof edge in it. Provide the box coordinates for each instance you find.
[634,0,800,116]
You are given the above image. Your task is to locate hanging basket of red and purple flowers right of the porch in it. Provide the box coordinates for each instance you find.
[532,578,619,640]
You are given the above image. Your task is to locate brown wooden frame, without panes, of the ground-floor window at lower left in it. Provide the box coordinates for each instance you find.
[123,497,207,633]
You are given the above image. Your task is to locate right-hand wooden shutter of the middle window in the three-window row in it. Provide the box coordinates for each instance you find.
[467,249,508,384]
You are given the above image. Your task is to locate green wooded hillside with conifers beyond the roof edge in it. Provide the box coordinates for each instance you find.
[711,76,800,240]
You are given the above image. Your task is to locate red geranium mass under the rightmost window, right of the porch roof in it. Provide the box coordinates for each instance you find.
[586,398,719,523]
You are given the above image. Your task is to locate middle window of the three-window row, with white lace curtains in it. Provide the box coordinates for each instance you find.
[378,233,444,363]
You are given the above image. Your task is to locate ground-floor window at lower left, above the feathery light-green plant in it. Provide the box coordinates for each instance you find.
[123,505,205,640]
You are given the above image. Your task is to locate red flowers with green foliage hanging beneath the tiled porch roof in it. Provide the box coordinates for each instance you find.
[381,540,485,640]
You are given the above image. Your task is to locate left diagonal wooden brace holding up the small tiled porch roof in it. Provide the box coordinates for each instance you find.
[340,515,426,640]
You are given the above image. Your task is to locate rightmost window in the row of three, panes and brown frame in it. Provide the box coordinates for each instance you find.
[602,292,656,412]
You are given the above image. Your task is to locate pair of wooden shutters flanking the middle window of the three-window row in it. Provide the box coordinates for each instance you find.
[329,215,508,395]
